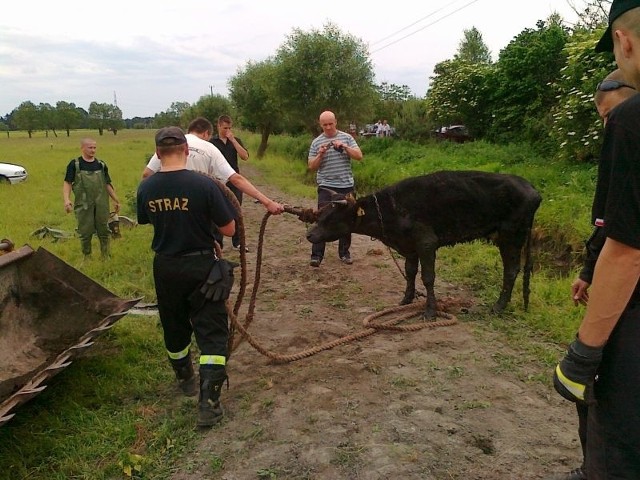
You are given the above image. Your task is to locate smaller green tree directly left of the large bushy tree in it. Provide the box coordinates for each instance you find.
[229,59,284,158]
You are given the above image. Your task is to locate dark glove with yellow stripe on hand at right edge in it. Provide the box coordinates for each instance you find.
[553,336,602,405]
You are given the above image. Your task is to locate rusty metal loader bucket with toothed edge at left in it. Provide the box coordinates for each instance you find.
[0,245,140,426]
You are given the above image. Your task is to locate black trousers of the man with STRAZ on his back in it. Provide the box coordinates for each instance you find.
[153,254,229,358]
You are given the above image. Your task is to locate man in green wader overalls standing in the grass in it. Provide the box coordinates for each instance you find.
[62,138,120,258]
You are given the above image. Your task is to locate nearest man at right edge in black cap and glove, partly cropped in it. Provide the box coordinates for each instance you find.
[553,0,640,480]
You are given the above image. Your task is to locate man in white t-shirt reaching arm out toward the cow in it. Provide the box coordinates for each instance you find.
[142,117,284,215]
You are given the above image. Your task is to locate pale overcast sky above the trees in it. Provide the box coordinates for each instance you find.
[0,0,584,118]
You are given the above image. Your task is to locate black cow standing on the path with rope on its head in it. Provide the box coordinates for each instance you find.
[307,171,542,319]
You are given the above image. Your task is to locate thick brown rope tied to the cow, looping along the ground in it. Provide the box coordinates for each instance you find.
[228,205,457,364]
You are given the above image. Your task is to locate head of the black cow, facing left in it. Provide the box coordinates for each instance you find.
[307,192,356,243]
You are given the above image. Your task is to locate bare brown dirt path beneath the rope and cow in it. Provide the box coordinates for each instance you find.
[173,167,580,480]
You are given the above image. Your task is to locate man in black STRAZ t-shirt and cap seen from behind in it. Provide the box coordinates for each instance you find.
[137,127,235,427]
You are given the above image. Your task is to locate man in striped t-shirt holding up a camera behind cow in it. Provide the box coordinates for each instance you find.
[308,110,362,267]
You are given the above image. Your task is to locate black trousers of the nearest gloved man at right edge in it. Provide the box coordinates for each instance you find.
[587,303,640,480]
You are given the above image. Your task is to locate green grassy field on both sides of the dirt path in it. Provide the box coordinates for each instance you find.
[0,130,595,480]
